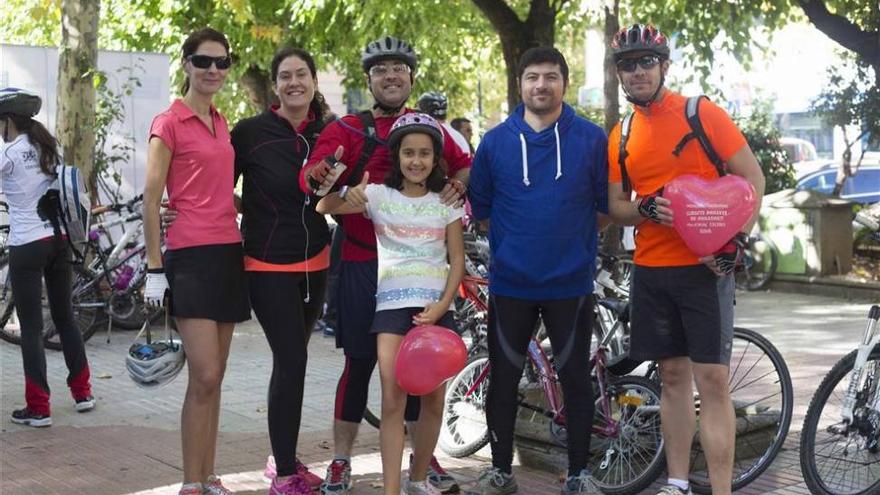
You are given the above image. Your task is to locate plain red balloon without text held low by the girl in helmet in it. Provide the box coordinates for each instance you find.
[394,325,467,395]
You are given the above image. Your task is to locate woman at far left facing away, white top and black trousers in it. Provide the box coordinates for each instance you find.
[0,88,95,426]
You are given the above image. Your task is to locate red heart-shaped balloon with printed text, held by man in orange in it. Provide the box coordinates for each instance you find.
[663,175,757,256]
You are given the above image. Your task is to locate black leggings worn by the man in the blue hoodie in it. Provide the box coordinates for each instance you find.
[486,294,595,475]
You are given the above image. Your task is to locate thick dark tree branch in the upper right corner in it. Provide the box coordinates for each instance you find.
[797,0,880,87]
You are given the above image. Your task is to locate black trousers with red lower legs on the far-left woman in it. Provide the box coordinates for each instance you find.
[9,240,92,415]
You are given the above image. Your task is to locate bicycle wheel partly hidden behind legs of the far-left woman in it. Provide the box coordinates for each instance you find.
[43,266,104,351]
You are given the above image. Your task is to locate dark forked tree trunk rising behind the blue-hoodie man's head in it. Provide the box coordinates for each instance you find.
[473,0,567,112]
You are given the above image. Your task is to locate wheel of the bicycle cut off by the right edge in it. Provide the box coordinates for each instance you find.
[800,346,880,495]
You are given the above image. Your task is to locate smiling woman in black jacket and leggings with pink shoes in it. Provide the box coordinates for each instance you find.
[232,48,330,494]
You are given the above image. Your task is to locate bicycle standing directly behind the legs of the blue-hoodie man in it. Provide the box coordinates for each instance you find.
[438,304,665,494]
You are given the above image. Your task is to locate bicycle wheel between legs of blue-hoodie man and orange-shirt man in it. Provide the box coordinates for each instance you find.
[588,376,666,494]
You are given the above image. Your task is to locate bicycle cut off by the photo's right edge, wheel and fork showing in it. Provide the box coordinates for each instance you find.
[800,305,880,495]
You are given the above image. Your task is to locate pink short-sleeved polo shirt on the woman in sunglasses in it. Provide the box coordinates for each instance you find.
[150,100,241,249]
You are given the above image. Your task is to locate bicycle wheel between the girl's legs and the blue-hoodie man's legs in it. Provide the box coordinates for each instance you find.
[437,353,489,457]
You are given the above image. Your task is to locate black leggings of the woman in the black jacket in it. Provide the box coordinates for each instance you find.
[247,271,327,476]
